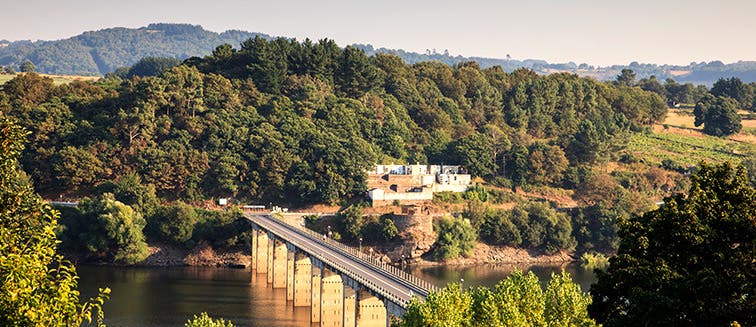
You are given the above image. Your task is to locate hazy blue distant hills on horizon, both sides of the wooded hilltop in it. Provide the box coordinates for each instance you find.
[0,24,756,85]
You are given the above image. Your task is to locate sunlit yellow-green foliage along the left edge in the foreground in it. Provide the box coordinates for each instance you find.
[0,117,110,326]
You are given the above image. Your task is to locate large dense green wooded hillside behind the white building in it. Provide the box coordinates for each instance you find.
[0,37,754,256]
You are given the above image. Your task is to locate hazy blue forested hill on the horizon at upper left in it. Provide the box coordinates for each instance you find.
[0,24,265,75]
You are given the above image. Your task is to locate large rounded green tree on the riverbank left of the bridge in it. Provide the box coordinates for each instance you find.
[63,193,148,265]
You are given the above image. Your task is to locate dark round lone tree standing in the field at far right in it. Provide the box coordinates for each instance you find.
[693,96,743,136]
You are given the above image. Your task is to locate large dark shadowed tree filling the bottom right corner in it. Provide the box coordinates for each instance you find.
[589,163,756,326]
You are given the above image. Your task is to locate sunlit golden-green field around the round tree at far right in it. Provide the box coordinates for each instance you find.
[627,110,756,165]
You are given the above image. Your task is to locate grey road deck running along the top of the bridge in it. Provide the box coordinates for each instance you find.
[245,213,435,308]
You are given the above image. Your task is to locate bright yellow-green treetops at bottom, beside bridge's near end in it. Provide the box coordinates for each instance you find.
[397,271,596,327]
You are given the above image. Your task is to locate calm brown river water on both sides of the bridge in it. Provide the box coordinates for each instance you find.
[78,265,593,327]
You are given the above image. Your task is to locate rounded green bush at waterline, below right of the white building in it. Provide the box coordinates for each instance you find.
[433,217,477,260]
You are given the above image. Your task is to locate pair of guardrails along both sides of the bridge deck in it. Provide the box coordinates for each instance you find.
[245,214,439,308]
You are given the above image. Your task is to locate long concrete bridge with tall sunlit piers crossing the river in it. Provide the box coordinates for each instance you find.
[244,212,437,327]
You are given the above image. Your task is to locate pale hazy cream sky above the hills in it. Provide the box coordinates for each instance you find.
[0,0,756,65]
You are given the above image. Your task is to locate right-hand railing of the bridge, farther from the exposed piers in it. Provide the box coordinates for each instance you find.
[271,215,439,297]
